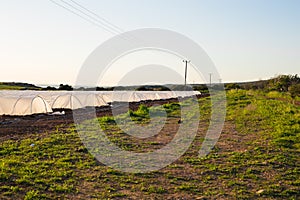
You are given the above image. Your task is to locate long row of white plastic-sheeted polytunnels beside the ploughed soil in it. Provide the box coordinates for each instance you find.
[0,90,200,115]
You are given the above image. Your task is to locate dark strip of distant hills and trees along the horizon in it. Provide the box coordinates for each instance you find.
[0,74,300,96]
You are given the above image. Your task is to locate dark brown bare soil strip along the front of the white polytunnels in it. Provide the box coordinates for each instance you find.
[0,95,207,141]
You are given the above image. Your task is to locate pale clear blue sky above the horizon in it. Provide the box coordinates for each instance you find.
[0,0,300,84]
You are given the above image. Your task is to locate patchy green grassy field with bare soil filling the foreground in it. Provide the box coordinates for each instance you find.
[0,90,300,199]
